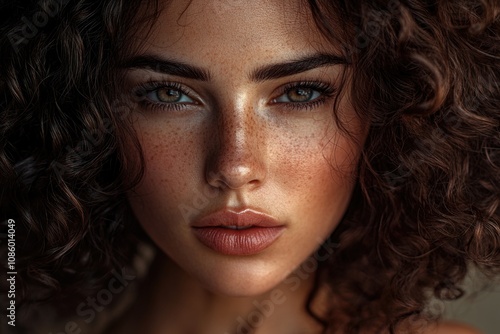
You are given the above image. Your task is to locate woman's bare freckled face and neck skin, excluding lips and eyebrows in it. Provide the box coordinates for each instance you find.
[116,0,480,334]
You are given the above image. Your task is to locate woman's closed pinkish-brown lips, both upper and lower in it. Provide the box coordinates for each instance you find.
[191,209,285,255]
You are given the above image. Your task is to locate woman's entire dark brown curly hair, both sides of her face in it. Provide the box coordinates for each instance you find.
[0,0,500,333]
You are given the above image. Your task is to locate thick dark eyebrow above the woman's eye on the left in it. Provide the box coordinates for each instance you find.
[120,55,210,81]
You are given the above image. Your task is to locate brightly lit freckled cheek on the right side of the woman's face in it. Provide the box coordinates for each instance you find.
[276,125,361,240]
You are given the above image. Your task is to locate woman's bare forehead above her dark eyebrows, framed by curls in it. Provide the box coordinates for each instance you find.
[129,0,337,66]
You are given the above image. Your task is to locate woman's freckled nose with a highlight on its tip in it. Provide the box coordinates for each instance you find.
[205,102,267,190]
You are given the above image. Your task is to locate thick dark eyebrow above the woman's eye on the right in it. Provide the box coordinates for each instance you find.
[251,53,349,81]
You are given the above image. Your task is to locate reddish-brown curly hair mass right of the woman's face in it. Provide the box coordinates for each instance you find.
[310,0,500,332]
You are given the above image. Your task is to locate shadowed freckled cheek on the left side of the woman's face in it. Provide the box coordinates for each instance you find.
[128,123,201,258]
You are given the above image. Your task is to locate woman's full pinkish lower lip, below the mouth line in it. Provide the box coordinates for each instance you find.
[194,226,285,255]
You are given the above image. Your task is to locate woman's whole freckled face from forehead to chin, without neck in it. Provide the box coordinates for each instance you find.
[124,0,366,296]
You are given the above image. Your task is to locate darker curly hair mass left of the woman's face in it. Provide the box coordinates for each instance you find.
[0,0,148,320]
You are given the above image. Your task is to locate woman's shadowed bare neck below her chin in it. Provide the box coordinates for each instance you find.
[116,254,328,334]
